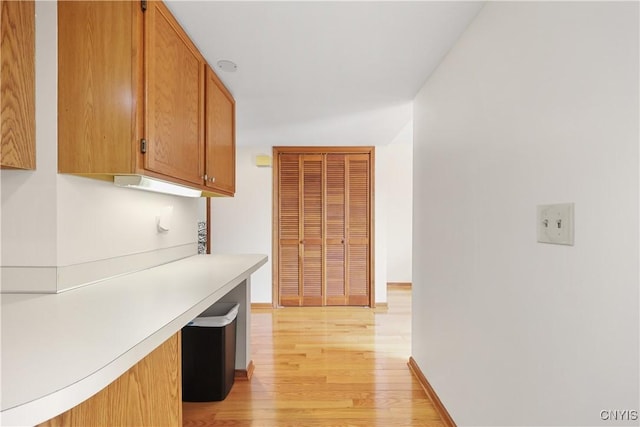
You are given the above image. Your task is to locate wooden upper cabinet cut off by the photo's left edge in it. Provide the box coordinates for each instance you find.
[0,0,36,169]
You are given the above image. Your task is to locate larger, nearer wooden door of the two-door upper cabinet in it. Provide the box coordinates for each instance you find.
[144,1,204,185]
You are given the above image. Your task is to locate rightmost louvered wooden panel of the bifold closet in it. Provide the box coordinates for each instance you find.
[345,154,371,305]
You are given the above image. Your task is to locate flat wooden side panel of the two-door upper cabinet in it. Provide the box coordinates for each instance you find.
[58,1,143,174]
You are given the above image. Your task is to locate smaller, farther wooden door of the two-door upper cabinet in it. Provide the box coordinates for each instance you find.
[205,66,236,196]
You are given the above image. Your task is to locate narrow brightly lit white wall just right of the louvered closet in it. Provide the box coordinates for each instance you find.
[378,121,413,282]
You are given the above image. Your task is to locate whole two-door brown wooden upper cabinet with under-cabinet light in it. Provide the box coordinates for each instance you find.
[58,1,235,196]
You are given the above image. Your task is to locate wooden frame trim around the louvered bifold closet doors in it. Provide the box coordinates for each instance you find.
[271,146,376,308]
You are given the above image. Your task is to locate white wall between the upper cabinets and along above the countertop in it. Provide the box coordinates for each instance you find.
[1,2,199,286]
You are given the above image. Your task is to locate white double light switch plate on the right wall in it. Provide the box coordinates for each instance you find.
[538,203,573,246]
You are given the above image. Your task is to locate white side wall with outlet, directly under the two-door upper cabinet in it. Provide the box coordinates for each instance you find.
[57,175,200,265]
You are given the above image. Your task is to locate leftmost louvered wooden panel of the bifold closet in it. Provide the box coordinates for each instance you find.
[277,154,302,306]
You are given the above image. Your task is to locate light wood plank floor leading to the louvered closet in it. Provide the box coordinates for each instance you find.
[183,288,443,427]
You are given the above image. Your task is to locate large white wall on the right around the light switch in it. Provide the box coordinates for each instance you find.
[412,2,640,426]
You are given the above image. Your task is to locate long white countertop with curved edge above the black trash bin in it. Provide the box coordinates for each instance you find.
[0,255,267,426]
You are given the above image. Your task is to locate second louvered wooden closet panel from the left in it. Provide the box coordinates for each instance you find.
[300,154,324,306]
